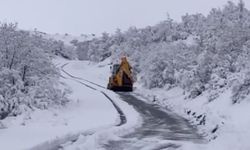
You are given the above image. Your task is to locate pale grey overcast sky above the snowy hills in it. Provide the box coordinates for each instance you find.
[0,0,247,35]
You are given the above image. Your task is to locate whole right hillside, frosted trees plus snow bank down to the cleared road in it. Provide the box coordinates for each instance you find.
[71,1,250,150]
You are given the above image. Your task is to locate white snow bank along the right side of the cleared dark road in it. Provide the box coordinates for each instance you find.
[135,85,250,150]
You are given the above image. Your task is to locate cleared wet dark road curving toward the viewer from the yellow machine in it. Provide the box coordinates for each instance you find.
[105,93,202,150]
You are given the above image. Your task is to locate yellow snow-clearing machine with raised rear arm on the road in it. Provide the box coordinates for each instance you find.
[108,57,133,91]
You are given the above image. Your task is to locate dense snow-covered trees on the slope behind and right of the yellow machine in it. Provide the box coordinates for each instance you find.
[76,1,250,102]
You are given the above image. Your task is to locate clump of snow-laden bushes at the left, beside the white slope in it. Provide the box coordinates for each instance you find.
[0,23,67,119]
